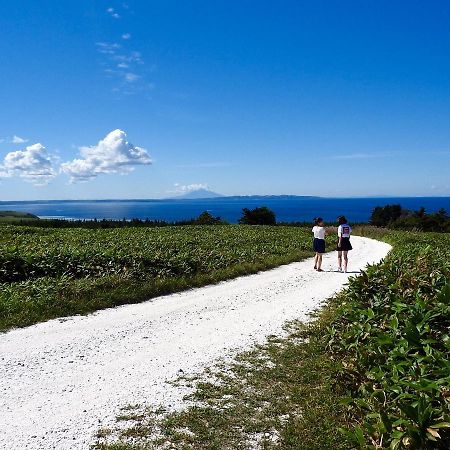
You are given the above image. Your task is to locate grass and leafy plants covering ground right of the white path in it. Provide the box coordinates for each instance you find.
[97,228,450,450]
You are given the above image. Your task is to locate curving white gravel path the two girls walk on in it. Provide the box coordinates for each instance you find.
[0,237,390,450]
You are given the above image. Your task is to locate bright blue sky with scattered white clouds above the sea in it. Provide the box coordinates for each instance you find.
[0,0,450,200]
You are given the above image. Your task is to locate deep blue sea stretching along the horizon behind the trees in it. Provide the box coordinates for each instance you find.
[0,195,450,223]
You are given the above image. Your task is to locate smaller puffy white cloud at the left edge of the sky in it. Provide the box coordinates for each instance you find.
[0,143,56,186]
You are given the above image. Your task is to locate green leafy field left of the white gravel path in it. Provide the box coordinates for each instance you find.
[0,225,320,330]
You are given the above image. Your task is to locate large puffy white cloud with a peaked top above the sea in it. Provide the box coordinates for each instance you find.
[61,130,152,182]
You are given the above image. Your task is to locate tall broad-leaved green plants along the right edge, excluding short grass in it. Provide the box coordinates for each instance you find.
[328,233,450,449]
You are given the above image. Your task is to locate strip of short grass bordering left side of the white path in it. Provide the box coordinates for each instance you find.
[0,252,311,332]
